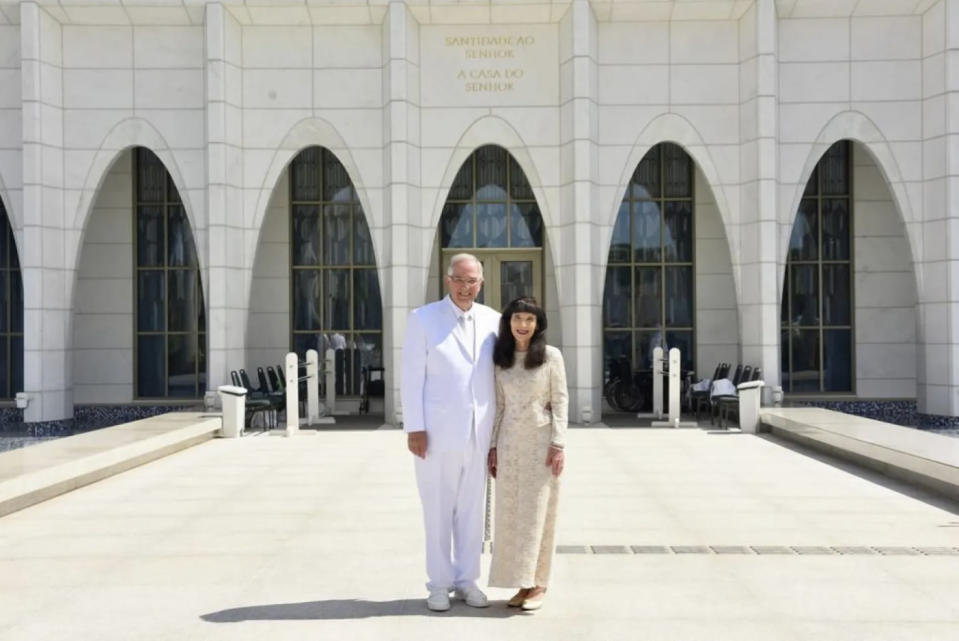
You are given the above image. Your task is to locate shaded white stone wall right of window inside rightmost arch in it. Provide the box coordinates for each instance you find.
[853,145,918,398]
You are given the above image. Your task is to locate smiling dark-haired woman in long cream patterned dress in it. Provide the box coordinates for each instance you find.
[489,297,569,610]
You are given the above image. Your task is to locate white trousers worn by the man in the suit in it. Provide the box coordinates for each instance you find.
[413,437,487,590]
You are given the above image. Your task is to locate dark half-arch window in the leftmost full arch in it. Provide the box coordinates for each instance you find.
[134,147,206,398]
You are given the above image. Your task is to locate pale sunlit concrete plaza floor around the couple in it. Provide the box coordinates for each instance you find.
[0,427,959,641]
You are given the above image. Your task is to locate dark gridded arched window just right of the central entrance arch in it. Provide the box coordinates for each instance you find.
[603,143,696,380]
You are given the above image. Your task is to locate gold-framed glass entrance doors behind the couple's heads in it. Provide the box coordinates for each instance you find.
[440,249,543,311]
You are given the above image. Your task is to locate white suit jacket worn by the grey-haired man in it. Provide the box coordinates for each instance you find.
[400,296,500,451]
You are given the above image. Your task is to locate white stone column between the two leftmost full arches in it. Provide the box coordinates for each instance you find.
[201,4,248,390]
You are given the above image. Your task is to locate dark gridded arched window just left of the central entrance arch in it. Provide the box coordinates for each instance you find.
[290,147,383,395]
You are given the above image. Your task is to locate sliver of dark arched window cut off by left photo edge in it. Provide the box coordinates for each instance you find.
[0,201,23,398]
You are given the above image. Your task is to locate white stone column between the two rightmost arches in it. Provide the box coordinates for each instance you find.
[730,0,785,395]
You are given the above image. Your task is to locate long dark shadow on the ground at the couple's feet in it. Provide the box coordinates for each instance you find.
[200,599,528,623]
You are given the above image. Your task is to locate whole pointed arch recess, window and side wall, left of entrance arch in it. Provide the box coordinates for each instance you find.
[246,141,384,397]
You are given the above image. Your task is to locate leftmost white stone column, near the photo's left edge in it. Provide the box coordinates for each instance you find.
[20,2,72,423]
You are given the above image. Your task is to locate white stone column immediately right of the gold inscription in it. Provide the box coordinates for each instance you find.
[550,0,608,422]
